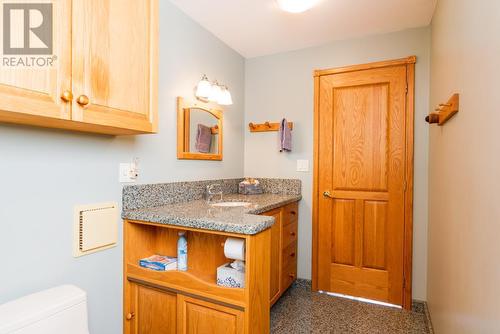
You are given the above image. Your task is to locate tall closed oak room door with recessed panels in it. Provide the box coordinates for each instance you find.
[315,57,413,305]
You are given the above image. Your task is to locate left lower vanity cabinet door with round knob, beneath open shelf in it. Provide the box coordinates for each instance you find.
[124,283,177,334]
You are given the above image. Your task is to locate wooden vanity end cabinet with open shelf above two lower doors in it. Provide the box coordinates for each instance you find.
[123,220,271,334]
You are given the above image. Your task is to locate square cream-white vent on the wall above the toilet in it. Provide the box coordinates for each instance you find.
[73,203,118,257]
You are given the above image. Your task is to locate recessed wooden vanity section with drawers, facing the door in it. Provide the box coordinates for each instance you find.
[263,202,299,305]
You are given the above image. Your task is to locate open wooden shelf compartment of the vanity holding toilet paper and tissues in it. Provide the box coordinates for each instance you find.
[124,222,245,307]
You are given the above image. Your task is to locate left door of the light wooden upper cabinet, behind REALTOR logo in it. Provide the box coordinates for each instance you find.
[0,0,71,122]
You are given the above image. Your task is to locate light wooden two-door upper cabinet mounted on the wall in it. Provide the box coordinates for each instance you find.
[0,0,158,135]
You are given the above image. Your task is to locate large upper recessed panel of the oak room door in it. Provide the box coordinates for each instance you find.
[333,84,389,191]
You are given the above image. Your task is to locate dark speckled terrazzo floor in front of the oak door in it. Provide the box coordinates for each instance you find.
[271,282,430,334]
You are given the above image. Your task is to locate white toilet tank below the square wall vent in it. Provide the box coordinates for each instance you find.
[0,285,89,334]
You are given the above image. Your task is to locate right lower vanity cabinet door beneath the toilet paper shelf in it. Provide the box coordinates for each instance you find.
[177,295,244,334]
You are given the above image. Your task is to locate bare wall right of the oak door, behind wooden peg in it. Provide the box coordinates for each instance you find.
[427,0,500,334]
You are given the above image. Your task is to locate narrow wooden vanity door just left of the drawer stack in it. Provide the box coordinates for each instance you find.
[264,209,282,305]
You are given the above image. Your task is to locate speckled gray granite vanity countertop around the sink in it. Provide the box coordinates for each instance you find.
[122,194,301,234]
